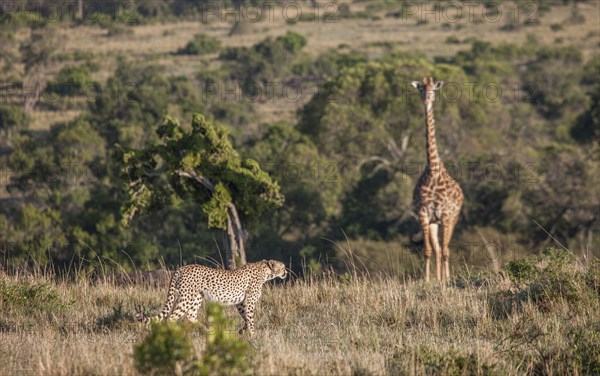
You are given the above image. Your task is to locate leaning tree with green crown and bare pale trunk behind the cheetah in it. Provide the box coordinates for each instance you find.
[119,114,283,269]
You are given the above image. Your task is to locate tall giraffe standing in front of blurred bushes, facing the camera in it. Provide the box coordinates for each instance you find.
[412,77,464,282]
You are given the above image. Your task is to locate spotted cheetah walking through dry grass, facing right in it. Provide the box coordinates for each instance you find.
[136,260,287,337]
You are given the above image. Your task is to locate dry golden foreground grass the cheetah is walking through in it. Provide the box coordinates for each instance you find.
[0,250,600,375]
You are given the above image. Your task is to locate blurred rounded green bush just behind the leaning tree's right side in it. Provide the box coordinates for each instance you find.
[245,123,343,242]
